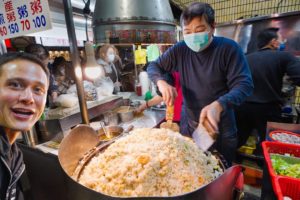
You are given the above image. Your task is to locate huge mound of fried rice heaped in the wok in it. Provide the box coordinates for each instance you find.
[79,128,222,197]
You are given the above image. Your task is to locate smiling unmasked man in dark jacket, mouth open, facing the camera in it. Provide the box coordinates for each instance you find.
[0,53,49,200]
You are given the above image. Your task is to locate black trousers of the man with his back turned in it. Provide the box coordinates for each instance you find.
[235,103,281,148]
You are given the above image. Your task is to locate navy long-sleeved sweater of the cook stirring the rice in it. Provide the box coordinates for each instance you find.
[147,37,253,133]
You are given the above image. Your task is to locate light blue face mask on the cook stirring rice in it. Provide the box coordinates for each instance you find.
[183,32,209,52]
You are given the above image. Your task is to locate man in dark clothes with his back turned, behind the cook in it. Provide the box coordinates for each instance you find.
[236,27,300,154]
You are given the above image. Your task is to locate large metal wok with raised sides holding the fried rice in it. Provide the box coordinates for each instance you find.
[58,125,243,200]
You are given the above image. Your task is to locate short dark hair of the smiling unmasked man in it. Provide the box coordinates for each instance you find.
[0,52,50,81]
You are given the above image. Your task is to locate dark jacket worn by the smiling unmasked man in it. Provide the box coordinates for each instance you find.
[0,126,25,200]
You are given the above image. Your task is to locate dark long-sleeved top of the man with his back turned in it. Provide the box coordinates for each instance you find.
[246,49,300,104]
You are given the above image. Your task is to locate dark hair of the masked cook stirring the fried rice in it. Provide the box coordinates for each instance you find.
[180,2,215,27]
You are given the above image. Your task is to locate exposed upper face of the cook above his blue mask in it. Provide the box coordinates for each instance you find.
[182,17,215,38]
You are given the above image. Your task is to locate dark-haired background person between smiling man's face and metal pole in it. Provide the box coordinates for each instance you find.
[49,56,75,102]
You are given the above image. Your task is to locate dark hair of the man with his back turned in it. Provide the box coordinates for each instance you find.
[257,27,279,49]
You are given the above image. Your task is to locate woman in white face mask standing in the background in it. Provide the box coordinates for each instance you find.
[96,44,122,93]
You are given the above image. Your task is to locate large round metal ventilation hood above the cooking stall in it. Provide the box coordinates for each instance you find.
[93,0,176,44]
